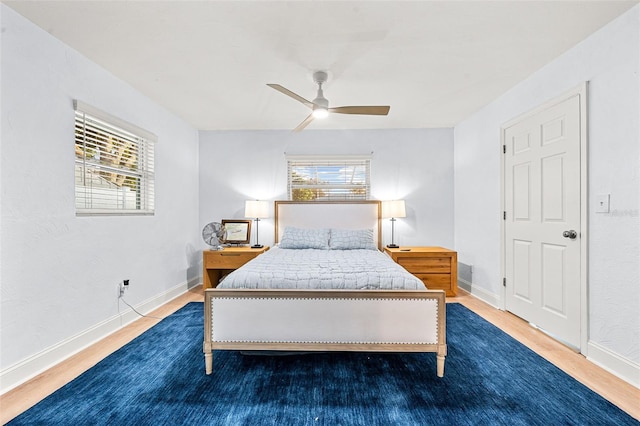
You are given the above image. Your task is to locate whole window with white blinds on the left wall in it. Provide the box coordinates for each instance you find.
[74,101,156,215]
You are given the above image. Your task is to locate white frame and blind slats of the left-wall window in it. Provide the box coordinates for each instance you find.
[73,100,158,216]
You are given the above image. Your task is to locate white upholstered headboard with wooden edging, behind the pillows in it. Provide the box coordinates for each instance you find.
[275,200,382,250]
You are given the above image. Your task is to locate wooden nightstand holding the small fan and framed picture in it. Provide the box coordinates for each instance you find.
[202,247,269,288]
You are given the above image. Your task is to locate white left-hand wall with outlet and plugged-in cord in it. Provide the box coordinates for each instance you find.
[0,5,201,390]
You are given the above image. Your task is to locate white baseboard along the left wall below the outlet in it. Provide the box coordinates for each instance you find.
[0,278,199,394]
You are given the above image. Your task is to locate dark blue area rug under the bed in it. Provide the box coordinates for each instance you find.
[10,303,638,426]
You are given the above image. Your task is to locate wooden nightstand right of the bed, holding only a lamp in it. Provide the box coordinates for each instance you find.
[384,247,458,296]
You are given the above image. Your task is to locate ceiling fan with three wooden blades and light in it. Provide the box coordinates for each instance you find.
[267,71,391,132]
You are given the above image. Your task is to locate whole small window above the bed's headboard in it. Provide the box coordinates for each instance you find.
[287,156,371,201]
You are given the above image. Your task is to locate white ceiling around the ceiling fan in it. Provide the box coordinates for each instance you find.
[4,0,639,130]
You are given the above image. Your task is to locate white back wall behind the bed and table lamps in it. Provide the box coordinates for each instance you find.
[200,129,453,247]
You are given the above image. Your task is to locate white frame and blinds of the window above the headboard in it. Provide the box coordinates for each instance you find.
[286,154,372,202]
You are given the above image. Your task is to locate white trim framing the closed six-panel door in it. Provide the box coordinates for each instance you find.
[499,82,589,356]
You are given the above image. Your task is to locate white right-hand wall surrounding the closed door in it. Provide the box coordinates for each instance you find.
[454,6,640,386]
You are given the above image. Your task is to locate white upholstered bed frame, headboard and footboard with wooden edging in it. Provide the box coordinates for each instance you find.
[203,201,447,377]
